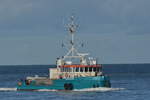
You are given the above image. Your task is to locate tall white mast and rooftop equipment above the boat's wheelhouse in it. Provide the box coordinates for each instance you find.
[57,16,96,66]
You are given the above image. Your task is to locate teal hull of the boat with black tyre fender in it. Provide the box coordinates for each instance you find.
[17,76,111,90]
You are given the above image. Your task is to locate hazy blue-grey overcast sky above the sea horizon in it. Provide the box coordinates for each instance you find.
[0,0,150,65]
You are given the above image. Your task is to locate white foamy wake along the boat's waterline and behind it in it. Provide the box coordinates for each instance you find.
[0,87,124,92]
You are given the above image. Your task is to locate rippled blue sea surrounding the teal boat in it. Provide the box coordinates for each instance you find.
[0,64,150,100]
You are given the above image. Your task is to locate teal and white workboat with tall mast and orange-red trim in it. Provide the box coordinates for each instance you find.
[17,16,111,91]
